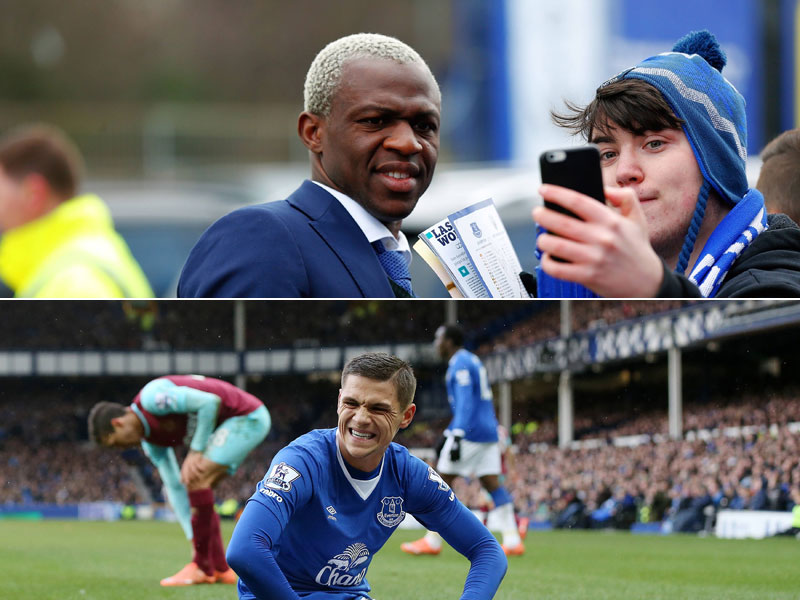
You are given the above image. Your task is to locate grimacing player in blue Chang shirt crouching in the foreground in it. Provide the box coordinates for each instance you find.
[228,353,508,600]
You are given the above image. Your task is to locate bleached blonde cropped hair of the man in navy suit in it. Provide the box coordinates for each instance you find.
[303,33,441,117]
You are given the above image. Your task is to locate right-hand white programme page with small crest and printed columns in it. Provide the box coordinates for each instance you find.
[448,198,529,298]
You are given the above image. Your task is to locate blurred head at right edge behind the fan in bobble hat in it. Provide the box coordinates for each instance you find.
[756,129,800,223]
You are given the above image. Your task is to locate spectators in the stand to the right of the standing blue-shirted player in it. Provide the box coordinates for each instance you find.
[511,420,800,531]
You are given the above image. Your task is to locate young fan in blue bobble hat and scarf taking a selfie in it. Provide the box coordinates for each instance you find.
[533,31,800,298]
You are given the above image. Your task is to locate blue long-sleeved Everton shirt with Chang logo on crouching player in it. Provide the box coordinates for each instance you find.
[228,429,507,600]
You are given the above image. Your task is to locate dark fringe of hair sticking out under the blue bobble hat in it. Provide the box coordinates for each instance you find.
[550,79,684,141]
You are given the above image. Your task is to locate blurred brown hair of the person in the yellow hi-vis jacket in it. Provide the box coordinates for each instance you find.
[0,124,83,200]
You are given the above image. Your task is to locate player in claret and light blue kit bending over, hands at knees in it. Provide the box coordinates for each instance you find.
[89,375,271,586]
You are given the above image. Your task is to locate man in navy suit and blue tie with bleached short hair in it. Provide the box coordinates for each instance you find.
[178,34,441,298]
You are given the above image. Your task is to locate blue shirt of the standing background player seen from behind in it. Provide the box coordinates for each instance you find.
[445,348,497,442]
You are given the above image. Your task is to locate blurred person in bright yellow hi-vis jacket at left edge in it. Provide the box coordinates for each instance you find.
[0,125,153,298]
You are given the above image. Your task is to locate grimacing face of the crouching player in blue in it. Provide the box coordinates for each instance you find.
[336,374,416,472]
